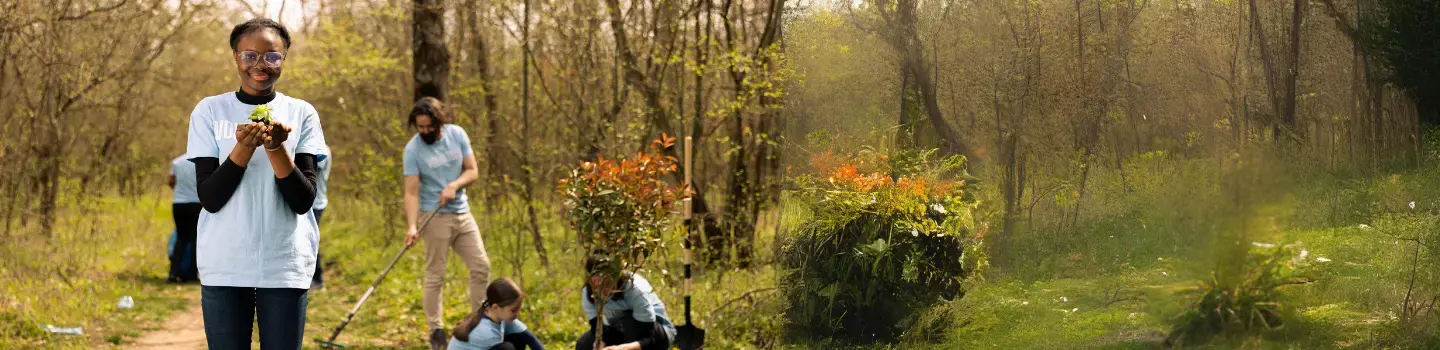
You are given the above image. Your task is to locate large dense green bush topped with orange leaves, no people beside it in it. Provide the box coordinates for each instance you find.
[779,153,988,343]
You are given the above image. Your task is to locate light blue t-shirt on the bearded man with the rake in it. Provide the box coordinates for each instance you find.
[405,124,474,213]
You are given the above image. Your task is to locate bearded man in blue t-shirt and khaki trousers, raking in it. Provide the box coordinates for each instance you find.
[403,97,490,349]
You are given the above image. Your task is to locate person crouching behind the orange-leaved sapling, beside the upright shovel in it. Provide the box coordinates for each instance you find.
[575,253,675,350]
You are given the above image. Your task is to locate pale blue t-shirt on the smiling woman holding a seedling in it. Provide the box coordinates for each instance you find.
[186,92,328,290]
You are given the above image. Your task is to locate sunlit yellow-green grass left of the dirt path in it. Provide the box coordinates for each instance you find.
[0,192,199,349]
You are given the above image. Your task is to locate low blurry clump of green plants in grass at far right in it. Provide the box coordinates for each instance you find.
[1166,243,1312,344]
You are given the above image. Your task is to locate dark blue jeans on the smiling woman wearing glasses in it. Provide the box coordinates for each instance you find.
[200,285,310,350]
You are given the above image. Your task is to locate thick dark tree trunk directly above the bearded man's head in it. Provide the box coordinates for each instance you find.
[410,0,446,101]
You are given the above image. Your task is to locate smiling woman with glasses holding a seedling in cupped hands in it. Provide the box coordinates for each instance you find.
[186,19,328,349]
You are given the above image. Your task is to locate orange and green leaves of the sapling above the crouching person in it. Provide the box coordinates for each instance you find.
[556,135,683,277]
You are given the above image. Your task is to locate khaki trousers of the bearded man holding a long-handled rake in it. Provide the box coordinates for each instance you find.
[420,213,490,330]
